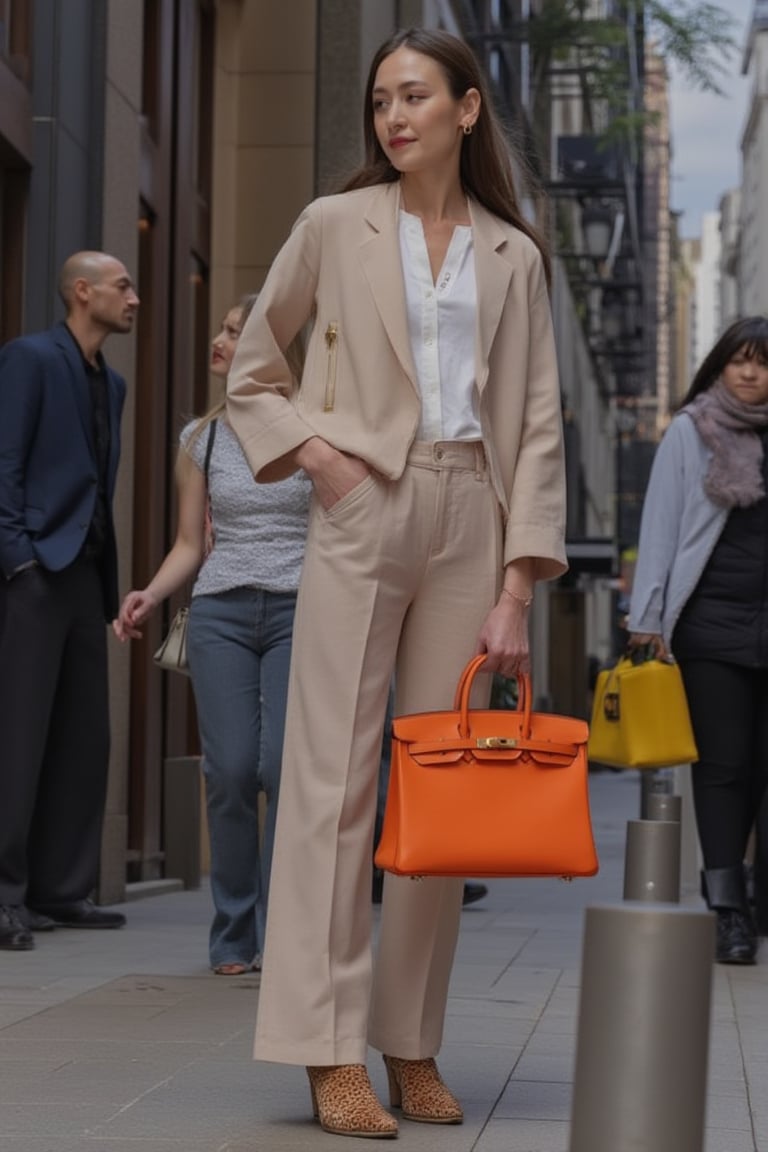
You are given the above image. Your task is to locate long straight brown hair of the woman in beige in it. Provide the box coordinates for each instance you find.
[341,28,552,282]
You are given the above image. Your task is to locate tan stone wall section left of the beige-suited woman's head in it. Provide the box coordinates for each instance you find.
[211,0,318,332]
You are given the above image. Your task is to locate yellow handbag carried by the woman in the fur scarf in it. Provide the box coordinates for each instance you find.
[588,657,699,768]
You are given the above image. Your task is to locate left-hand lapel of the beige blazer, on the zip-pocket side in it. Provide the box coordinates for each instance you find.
[359,182,419,392]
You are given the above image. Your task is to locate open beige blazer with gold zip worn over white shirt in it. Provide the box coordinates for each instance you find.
[227,182,567,579]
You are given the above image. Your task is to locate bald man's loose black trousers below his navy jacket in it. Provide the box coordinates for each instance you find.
[0,560,109,907]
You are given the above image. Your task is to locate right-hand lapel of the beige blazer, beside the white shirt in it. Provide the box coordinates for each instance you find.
[469,199,514,392]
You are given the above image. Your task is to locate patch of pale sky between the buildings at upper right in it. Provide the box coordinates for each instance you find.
[669,0,753,236]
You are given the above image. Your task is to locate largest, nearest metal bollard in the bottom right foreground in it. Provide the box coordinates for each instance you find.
[570,904,715,1152]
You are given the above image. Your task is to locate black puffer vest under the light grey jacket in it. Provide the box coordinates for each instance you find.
[672,432,768,668]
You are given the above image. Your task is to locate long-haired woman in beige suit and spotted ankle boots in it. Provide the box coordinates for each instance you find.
[228,30,565,1136]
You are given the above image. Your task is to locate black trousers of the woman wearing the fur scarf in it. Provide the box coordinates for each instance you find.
[680,660,768,870]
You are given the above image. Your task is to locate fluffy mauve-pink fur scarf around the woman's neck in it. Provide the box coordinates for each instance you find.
[684,380,768,508]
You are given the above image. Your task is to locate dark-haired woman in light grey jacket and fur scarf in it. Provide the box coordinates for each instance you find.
[629,317,768,964]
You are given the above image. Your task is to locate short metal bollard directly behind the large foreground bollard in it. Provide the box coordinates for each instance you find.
[624,820,680,903]
